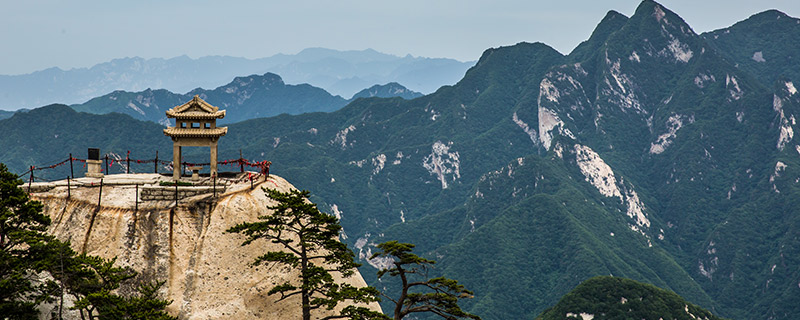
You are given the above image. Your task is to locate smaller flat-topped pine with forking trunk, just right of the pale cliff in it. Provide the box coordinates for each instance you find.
[370,241,480,320]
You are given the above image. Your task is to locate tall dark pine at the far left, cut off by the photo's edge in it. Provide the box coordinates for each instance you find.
[0,163,50,319]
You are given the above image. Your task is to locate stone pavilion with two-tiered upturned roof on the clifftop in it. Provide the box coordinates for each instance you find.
[164,95,228,181]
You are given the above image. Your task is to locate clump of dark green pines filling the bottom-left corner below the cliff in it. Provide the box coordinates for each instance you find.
[0,163,177,320]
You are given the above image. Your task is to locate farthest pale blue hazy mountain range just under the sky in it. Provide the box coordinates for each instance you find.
[0,48,474,110]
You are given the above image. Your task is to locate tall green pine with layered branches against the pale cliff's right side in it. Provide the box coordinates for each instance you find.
[226,189,386,320]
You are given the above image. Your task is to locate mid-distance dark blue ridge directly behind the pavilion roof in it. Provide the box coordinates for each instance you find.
[72,73,422,125]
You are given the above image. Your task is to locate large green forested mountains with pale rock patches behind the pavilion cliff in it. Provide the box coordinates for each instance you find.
[0,0,800,319]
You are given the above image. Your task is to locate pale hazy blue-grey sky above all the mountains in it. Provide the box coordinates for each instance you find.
[0,0,800,74]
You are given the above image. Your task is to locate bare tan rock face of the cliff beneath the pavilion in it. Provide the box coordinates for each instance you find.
[31,174,380,319]
